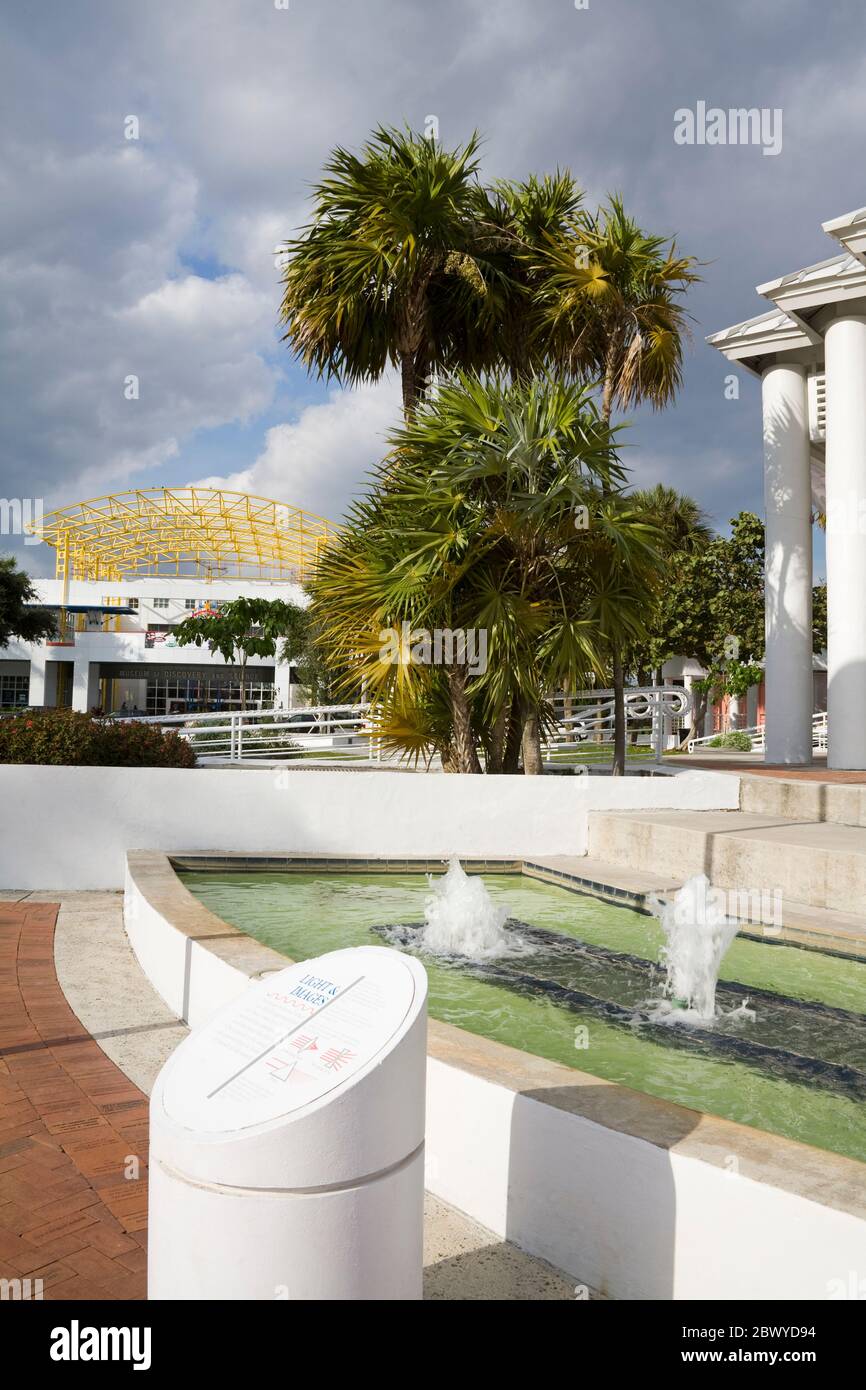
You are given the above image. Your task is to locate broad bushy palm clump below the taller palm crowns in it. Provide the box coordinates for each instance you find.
[313,377,657,773]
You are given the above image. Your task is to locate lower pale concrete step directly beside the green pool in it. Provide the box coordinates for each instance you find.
[589,810,866,922]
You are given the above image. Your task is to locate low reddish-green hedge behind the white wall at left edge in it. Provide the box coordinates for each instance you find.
[0,709,196,767]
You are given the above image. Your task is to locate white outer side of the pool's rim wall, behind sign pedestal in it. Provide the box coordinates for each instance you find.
[124,856,866,1301]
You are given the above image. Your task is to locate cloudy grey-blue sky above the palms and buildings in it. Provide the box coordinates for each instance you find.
[0,0,866,573]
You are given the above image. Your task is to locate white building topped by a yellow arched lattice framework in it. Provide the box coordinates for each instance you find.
[0,488,332,714]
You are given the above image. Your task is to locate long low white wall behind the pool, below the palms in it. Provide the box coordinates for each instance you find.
[0,765,740,888]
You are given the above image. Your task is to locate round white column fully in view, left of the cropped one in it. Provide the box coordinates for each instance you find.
[763,363,812,763]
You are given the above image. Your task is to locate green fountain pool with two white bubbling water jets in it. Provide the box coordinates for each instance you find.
[183,863,866,1158]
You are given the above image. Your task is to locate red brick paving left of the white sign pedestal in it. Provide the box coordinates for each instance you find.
[0,902,147,1300]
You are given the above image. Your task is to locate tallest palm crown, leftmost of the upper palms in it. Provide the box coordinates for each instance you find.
[281,126,496,418]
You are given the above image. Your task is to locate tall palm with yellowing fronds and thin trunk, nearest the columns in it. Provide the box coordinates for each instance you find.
[545,196,699,776]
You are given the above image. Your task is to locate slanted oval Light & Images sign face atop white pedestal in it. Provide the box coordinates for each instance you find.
[164,947,416,1133]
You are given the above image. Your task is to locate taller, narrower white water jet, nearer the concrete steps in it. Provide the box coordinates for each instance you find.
[652,874,748,1022]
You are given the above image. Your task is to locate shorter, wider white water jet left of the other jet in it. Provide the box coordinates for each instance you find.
[418,855,523,960]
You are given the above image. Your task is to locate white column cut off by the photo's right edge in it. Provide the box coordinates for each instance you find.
[824,316,866,769]
